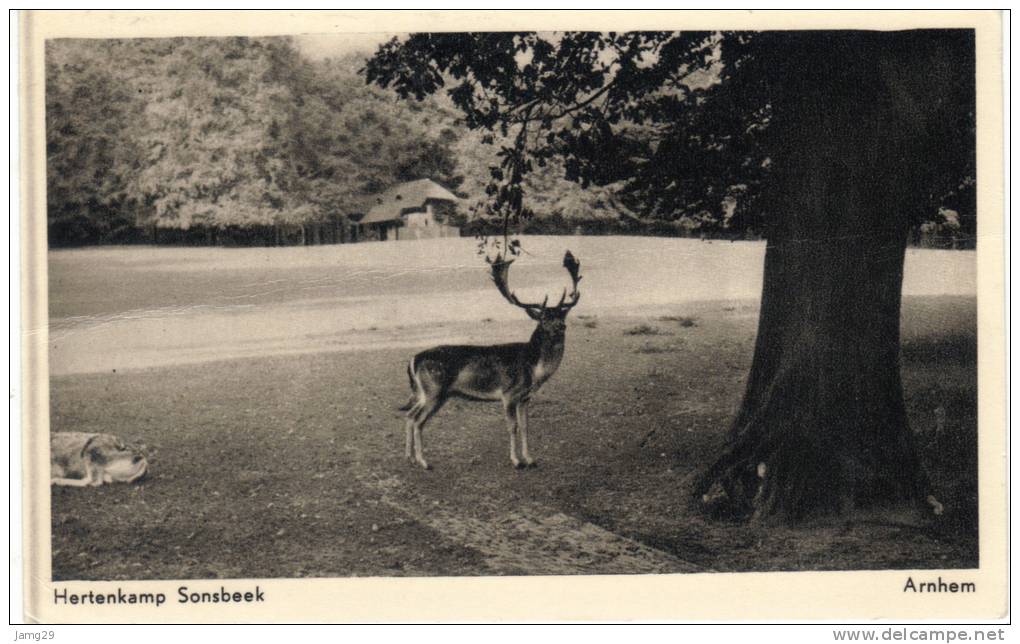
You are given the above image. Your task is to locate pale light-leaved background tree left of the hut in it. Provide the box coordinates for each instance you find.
[133,38,307,234]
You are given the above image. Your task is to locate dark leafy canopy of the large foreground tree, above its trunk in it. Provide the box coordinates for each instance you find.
[367,30,974,235]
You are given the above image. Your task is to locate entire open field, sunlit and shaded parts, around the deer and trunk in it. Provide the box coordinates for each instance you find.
[49,238,977,580]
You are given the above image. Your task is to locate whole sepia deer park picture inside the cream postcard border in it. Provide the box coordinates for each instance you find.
[23,11,1006,620]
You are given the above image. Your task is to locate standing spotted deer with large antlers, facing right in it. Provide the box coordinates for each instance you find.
[401,251,580,469]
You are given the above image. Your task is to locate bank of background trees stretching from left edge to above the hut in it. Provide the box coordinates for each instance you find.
[46,38,463,245]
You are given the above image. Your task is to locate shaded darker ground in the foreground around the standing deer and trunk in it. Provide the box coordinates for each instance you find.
[51,255,977,580]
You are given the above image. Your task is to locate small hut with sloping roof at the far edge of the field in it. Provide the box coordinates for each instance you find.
[352,179,460,242]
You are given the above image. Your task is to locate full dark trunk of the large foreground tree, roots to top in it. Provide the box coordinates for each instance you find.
[697,35,958,521]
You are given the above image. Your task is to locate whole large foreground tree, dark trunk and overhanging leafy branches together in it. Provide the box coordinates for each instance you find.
[367,31,974,519]
